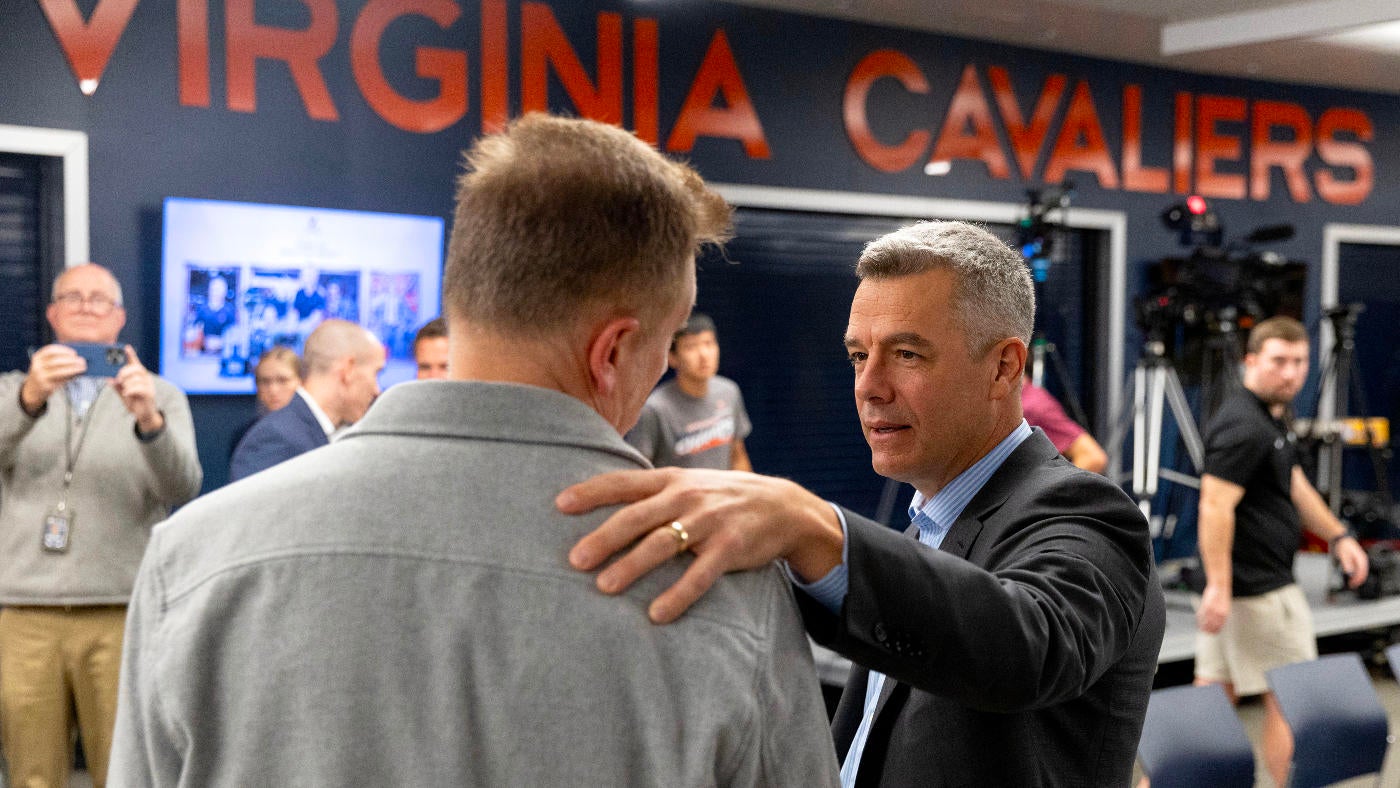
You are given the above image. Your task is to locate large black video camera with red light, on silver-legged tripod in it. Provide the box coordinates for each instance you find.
[1134,195,1308,378]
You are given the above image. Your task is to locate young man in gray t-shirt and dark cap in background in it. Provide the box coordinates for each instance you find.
[627,314,753,470]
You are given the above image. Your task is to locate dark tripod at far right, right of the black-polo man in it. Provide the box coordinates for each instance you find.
[1310,304,1393,514]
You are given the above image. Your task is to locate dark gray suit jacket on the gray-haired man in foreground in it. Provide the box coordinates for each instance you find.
[798,430,1165,787]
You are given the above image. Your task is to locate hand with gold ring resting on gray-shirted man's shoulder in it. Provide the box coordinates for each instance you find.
[554,467,841,624]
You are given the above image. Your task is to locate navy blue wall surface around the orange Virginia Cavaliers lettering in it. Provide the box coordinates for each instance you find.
[0,0,1400,498]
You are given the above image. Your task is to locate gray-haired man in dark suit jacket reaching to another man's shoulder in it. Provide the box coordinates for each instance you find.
[557,223,1165,787]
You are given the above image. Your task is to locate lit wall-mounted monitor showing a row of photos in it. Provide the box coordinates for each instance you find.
[161,197,444,393]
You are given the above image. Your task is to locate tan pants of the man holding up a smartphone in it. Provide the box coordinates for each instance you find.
[0,606,126,788]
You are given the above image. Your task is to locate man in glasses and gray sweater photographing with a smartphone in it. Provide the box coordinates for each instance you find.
[0,263,202,787]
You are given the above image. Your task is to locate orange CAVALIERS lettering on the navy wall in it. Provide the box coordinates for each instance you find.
[843,49,1375,204]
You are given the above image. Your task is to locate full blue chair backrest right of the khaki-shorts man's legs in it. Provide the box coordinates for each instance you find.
[1268,654,1389,788]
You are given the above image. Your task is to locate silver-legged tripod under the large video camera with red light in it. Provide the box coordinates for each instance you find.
[1107,339,1205,537]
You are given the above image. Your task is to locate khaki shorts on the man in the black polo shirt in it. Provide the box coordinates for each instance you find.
[1191,584,1317,697]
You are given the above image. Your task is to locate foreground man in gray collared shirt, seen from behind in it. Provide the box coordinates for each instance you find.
[112,115,836,788]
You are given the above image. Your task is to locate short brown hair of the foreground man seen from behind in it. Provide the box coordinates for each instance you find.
[442,113,729,336]
